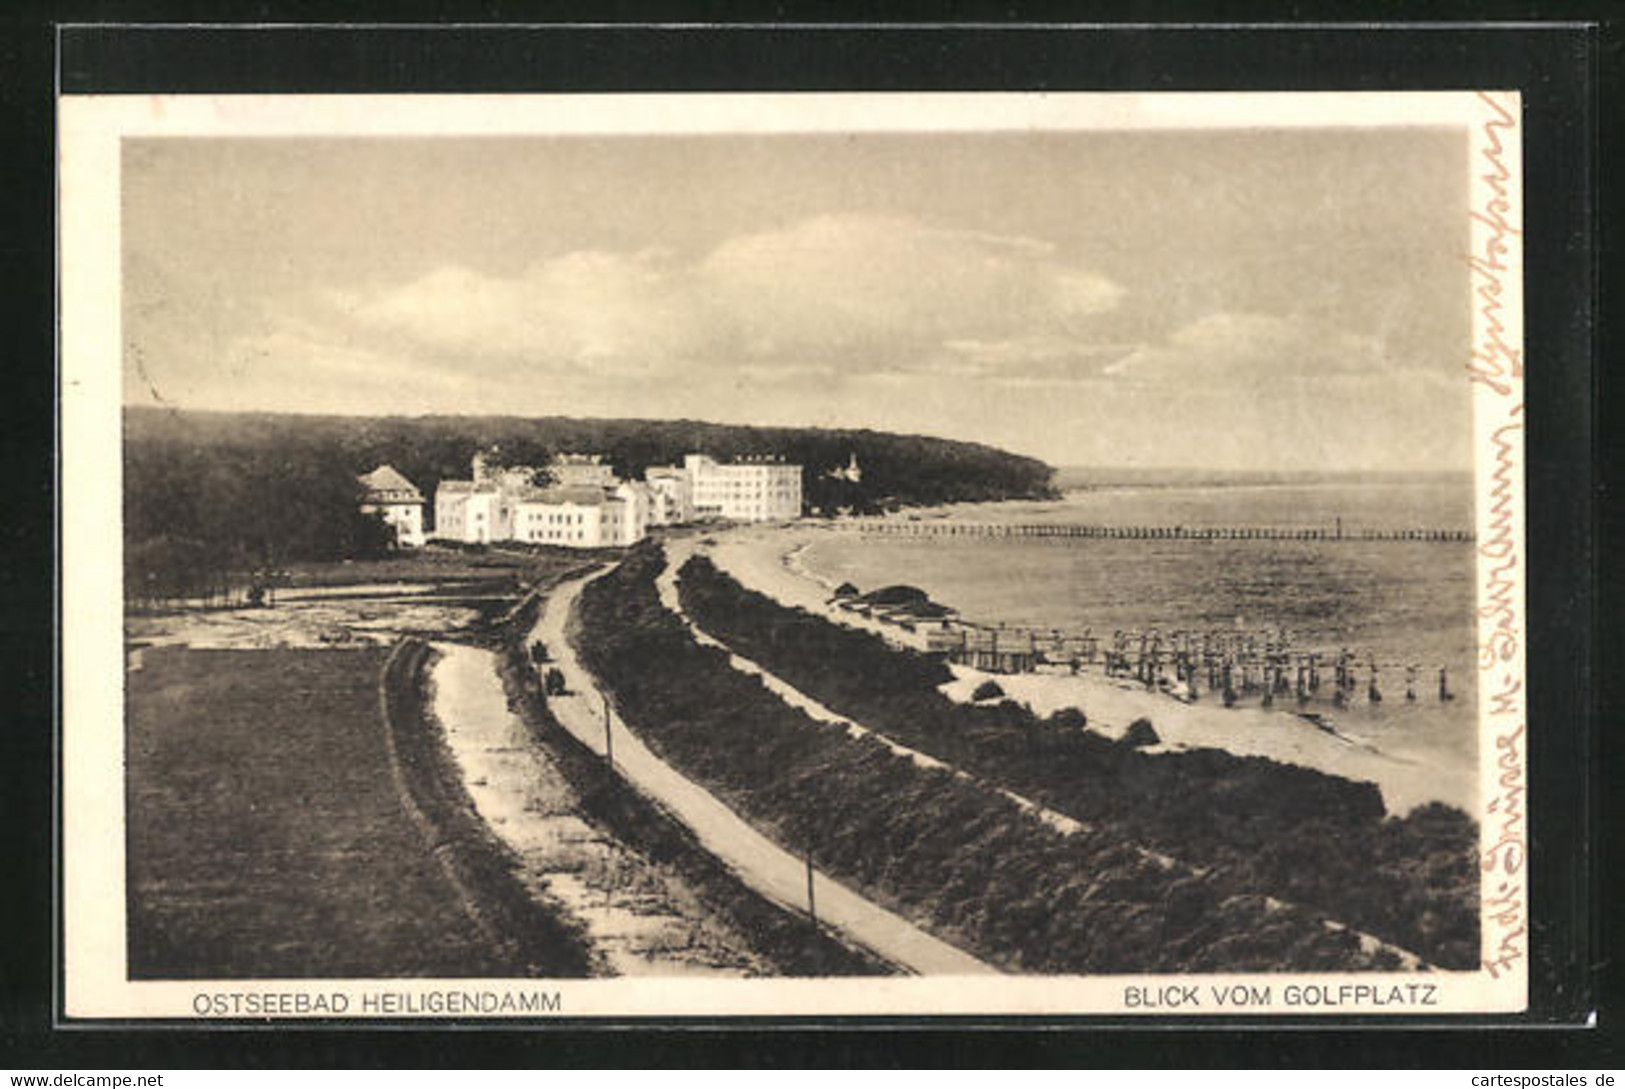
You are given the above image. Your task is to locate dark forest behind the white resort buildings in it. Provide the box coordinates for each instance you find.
[124,408,1055,597]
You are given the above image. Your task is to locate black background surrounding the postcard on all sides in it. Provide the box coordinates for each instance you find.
[0,2,1625,1071]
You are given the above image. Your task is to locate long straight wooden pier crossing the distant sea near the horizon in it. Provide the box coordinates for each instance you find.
[834,518,1474,543]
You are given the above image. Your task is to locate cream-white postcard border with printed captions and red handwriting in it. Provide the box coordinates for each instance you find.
[59,91,1529,1019]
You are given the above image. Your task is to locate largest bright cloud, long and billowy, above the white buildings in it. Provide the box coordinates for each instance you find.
[327,215,1123,379]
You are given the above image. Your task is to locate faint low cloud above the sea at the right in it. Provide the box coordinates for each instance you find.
[1103,312,1406,384]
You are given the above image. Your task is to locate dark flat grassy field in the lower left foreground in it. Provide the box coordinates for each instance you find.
[125,647,565,978]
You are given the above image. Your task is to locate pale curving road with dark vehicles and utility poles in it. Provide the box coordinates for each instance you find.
[531,572,996,975]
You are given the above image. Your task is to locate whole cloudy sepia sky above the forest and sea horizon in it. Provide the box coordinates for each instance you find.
[122,128,1471,470]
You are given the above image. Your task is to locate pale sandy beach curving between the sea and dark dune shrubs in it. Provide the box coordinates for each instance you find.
[696,523,1476,814]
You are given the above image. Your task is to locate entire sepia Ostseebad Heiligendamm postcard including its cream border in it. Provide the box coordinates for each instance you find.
[60,89,1539,1022]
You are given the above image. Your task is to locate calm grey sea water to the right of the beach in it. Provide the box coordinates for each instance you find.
[795,476,1476,780]
